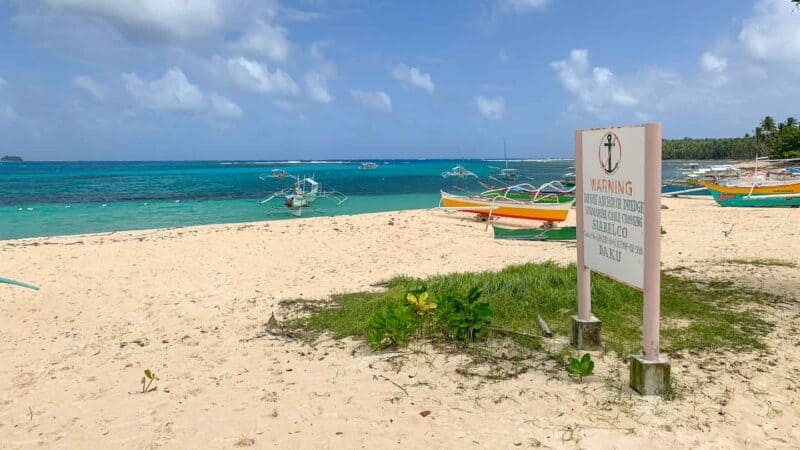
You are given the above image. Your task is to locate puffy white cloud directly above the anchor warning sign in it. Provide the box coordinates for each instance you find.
[550,49,639,114]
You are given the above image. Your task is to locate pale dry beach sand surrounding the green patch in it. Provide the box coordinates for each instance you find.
[0,199,800,448]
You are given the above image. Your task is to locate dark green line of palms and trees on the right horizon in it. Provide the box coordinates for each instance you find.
[662,116,800,160]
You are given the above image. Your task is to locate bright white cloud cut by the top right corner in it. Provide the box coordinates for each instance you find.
[739,0,800,64]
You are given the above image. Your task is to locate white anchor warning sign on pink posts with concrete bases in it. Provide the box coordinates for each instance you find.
[572,124,670,395]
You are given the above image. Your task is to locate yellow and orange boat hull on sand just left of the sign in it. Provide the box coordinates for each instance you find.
[440,191,574,222]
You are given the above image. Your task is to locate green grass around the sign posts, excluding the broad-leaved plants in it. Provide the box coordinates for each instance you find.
[287,263,775,355]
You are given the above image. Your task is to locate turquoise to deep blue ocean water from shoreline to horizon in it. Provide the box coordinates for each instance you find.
[0,160,692,239]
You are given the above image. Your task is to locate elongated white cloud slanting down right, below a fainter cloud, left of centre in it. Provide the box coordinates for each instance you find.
[223,56,300,95]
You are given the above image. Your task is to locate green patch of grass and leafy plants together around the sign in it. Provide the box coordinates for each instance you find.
[285,263,780,356]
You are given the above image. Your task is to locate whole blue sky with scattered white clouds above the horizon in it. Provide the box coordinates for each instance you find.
[0,0,800,160]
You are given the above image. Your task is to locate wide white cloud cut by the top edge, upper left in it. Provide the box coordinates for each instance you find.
[40,0,223,39]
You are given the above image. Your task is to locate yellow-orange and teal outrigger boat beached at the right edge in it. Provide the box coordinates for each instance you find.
[702,182,800,208]
